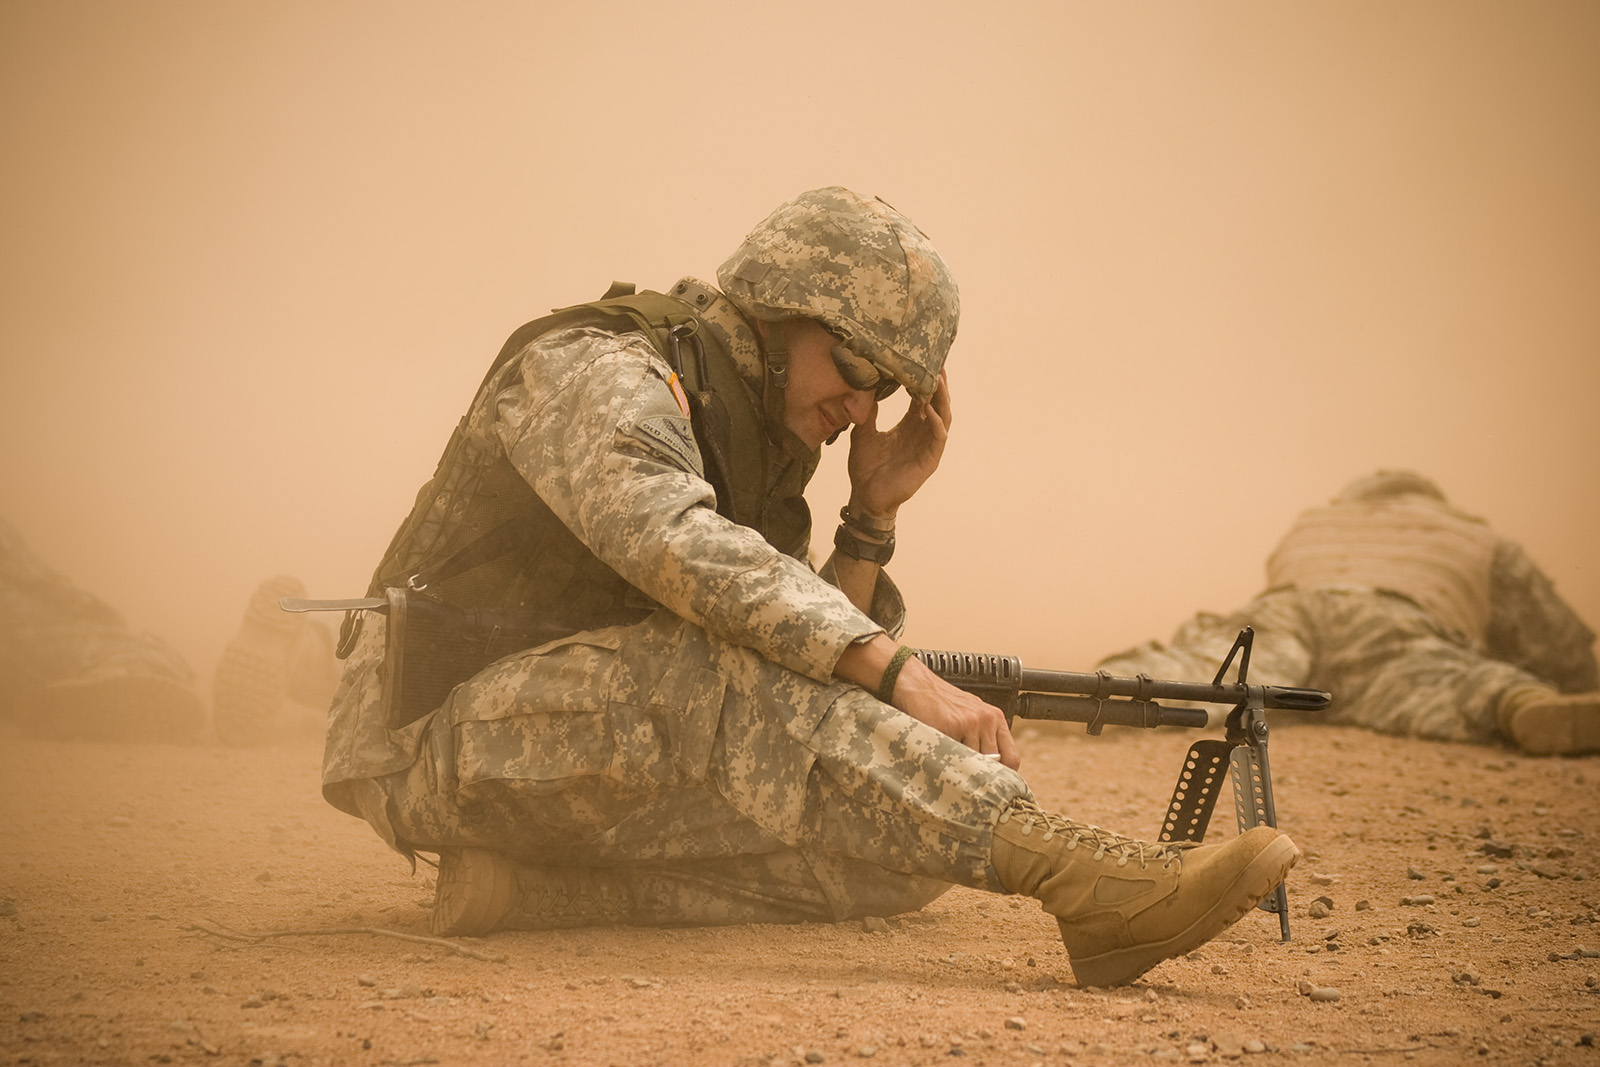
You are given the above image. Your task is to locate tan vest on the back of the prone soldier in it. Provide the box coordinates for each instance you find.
[1267,498,1498,648]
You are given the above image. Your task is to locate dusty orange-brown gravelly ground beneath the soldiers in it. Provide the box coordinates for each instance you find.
[0,716,1600,1067]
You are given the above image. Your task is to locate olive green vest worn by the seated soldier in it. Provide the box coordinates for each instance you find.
[339,286,816,657]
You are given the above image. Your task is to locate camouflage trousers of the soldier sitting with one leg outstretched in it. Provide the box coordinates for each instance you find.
[379,611,1029,925]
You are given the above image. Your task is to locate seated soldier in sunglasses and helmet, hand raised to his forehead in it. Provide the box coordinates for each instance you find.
[323,187,1299,985]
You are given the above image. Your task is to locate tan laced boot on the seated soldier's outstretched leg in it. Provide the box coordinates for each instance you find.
[989,800,1299,985]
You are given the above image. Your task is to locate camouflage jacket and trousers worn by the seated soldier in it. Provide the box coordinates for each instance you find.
[325,278,1027,923]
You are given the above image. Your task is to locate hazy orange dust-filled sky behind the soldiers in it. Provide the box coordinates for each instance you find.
[0,0,1600,684]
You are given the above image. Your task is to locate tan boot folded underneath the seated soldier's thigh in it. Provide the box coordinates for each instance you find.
[429,848,634,937]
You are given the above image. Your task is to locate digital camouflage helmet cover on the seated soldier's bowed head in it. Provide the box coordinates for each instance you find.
[717,186,960,402]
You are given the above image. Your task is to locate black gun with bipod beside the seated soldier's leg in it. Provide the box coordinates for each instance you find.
[915,625,1333,941]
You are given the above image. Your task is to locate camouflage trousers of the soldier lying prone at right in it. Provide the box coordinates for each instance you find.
[1099,589,1541,742]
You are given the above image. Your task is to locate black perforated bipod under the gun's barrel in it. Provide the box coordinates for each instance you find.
[1160,625,1290,941]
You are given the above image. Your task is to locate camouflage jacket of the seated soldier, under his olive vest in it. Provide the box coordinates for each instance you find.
[323,278,904,796]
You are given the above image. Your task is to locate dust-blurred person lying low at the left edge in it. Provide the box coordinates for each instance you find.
[0,520,205,742]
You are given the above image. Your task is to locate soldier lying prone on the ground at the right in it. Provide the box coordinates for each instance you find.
[1099,470,1600,755]
